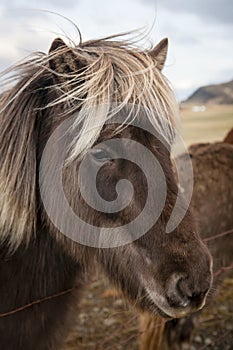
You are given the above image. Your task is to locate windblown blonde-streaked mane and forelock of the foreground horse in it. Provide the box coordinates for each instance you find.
[0,31,178,244]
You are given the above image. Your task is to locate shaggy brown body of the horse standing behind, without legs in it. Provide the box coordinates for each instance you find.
[177,141,233,271]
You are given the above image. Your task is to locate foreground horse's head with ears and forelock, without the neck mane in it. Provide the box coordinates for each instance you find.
[38,40,212,317]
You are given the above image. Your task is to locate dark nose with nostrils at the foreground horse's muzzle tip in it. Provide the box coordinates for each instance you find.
[166,274,210,309]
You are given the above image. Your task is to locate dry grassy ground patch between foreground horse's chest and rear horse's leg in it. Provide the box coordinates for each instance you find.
[63,277,139,350]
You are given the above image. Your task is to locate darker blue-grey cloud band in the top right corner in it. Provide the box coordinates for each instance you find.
[146,0,233,25]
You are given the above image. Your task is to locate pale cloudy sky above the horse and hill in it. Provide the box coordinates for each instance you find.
[0,0,233,100]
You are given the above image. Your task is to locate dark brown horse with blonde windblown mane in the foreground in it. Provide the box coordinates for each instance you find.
[0,31,212,350]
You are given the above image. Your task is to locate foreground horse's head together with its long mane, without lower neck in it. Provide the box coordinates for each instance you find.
[0,32,211,317]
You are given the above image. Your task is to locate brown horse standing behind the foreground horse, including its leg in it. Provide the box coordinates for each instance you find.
[141,129,233,350]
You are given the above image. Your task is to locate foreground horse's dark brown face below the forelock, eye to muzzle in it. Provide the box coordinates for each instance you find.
[60,125,212,318]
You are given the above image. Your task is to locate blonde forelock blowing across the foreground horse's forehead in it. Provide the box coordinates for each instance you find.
[48,38,178,159]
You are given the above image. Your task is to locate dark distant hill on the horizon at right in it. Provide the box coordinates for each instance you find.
[183,80,233,105]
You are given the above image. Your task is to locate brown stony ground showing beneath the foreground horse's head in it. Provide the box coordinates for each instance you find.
[63,278,233,350]
